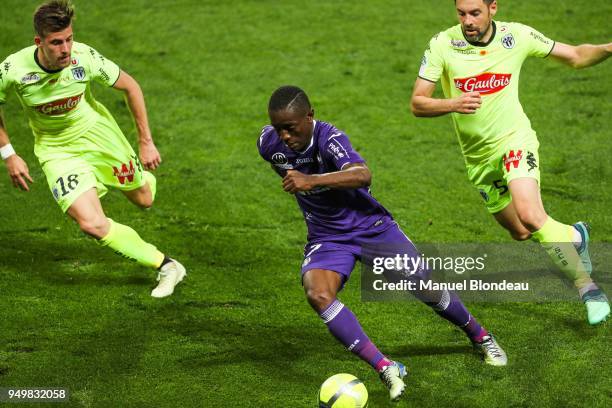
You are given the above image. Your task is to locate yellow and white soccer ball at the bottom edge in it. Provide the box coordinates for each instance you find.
[319,374,368,408]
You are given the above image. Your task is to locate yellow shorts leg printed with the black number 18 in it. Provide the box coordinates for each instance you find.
[42,149,106,212]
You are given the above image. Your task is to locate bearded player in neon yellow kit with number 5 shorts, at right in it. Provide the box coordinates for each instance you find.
[411,0,612,324]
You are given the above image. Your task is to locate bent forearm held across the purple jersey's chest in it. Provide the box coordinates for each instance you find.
[283,163,372,194]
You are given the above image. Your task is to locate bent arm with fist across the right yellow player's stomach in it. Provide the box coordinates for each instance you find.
[410,78,482,117]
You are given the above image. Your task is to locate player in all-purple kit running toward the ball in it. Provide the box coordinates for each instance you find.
[257,86,507,401]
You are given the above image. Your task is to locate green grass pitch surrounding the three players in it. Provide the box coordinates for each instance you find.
[0,0,612,407]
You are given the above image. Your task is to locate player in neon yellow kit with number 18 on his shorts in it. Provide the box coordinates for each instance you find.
[0,0,185,297]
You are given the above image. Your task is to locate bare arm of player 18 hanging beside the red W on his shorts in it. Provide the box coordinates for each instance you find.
[113,71,161,170]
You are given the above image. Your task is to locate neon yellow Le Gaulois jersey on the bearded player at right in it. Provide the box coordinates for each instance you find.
[419,22,554,164]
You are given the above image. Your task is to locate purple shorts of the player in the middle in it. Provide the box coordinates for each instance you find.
[302,218,420,284]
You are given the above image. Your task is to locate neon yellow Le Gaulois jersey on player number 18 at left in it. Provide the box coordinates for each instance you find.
[0,42,120,146]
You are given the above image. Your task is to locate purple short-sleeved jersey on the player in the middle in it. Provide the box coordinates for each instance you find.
[257,121,391,241]
